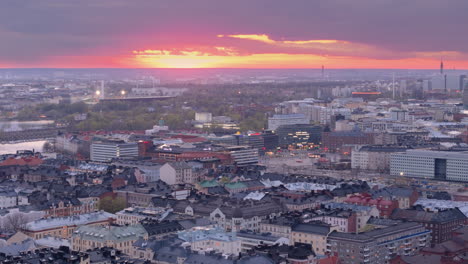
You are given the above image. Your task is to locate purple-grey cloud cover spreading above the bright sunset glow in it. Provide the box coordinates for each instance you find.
[0,0,468,65]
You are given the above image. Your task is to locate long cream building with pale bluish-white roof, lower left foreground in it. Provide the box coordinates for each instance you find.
[21,211,116,239]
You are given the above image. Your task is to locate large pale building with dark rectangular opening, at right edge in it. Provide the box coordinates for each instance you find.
[390,150,468,182]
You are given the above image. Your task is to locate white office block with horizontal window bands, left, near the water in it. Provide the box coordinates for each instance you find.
[91,141,138,162]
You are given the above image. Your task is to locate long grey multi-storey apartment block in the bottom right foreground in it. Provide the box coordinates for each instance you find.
[327,222,431,264]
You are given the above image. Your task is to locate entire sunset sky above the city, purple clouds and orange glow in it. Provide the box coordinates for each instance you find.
[0,0,468,69]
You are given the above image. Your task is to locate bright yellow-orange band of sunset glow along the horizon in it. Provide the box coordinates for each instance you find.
[131,50,468,69]
